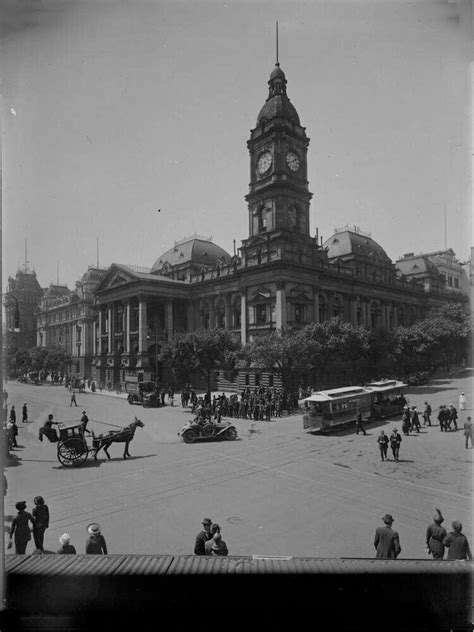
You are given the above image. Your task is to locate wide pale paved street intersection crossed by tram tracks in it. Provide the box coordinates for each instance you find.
[1,371,473,558]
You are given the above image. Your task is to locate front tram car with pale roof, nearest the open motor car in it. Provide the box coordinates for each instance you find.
[303,386,373,430]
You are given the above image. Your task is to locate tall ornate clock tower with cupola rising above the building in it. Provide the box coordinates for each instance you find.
[244,62,312,246]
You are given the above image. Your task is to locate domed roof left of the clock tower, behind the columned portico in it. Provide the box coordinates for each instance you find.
[151,237,231,272]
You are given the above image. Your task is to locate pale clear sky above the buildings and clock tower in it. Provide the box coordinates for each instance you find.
[0,0,472,288]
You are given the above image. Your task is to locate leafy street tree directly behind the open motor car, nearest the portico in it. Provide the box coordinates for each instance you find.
[163,329,240,392]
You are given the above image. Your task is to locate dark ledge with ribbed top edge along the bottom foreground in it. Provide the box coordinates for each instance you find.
[1,554,473,631]
